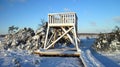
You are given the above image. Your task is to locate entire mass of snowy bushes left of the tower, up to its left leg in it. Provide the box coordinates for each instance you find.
[0,25,46,51]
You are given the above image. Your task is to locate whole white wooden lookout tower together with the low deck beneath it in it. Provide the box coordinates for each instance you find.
[34,12,80,56]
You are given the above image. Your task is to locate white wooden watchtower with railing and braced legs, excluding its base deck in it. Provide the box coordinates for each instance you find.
[44,12,79,51]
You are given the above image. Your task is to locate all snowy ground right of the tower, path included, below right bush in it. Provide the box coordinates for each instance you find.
[80,39,120,67]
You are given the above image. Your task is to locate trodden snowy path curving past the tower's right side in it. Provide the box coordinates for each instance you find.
[80,39,120,67]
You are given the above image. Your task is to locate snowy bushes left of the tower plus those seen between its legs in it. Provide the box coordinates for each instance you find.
[0,23,70,51]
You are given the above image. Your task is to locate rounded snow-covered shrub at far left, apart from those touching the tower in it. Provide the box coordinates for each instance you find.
[2,28,35,49]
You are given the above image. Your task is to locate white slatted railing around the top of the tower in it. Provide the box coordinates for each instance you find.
[48,12,77,26]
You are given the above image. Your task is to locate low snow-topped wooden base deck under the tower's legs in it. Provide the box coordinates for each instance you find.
[34,50,80,57]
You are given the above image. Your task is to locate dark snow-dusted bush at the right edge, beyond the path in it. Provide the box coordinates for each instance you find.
[93,26,120,51]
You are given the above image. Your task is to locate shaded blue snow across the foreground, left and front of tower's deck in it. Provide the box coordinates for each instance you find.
[0,50,82,67]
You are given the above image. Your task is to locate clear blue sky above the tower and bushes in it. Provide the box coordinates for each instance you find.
[0,0,120,34]
